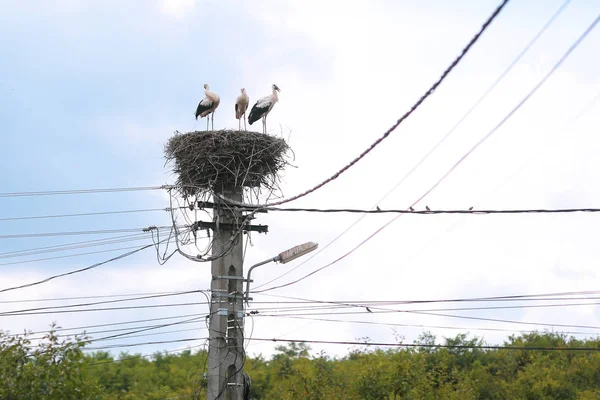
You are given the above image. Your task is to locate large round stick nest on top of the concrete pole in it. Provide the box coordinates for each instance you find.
[164,130,290,197]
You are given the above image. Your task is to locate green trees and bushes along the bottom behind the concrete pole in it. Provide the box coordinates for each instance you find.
[0,332,600,400]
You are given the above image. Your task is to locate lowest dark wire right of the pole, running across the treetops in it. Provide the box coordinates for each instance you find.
[252,338,600,351]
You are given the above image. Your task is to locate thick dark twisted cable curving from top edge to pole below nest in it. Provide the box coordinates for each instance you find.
[213,0,508,207]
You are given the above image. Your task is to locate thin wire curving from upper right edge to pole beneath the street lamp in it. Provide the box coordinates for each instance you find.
[257,15,600,293]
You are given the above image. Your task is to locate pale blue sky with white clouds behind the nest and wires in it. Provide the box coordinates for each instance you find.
[0,0,600,355]
